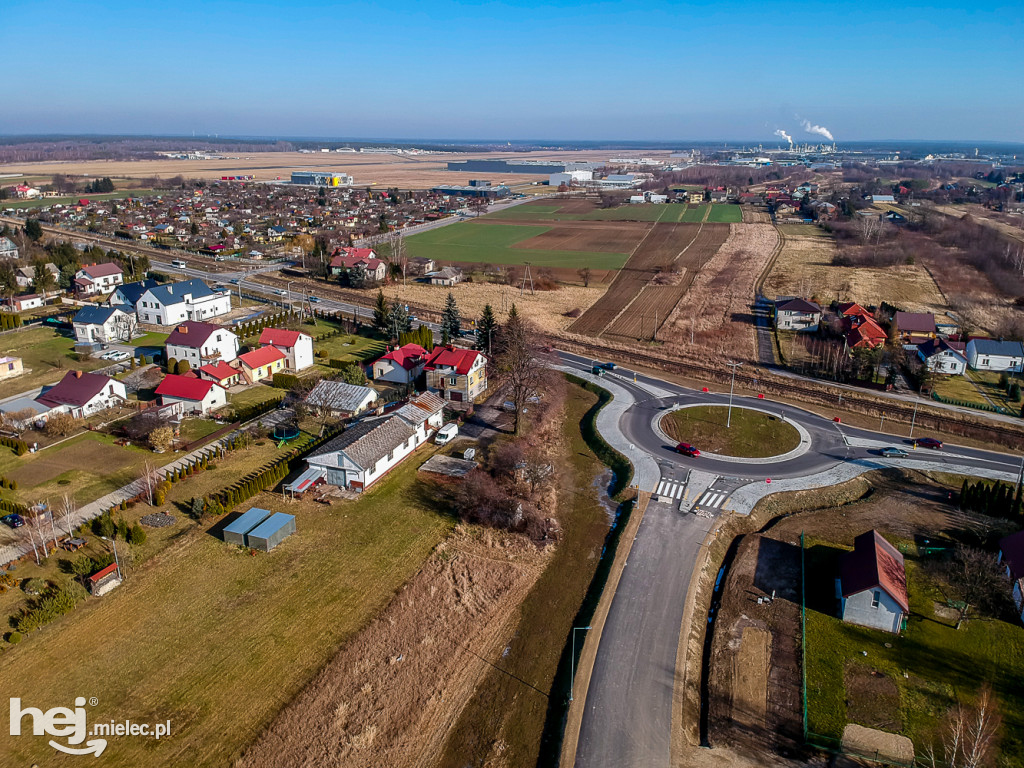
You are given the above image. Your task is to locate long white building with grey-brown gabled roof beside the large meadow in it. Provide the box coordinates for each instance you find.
[306,416,427,490]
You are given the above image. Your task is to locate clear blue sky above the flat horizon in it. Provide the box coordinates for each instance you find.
[0,0,1024,141]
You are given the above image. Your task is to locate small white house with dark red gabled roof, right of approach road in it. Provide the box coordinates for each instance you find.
[837,530,910,634]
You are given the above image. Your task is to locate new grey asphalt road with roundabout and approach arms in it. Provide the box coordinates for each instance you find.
[560,352,1021,768]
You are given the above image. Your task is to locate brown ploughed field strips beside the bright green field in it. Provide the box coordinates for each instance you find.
[568,224,729,341]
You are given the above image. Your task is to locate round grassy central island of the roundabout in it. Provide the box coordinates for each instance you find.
[662,406,800,458]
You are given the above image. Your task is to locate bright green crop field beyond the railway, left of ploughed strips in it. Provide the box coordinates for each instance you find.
[406,219,629,269]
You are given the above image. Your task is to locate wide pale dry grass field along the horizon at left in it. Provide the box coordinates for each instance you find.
[0,151,667,188]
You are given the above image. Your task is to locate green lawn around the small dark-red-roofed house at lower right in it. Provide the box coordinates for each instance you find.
[806,545,1024,766]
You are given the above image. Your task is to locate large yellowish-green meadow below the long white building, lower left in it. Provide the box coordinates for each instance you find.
[0,450,452,768]
